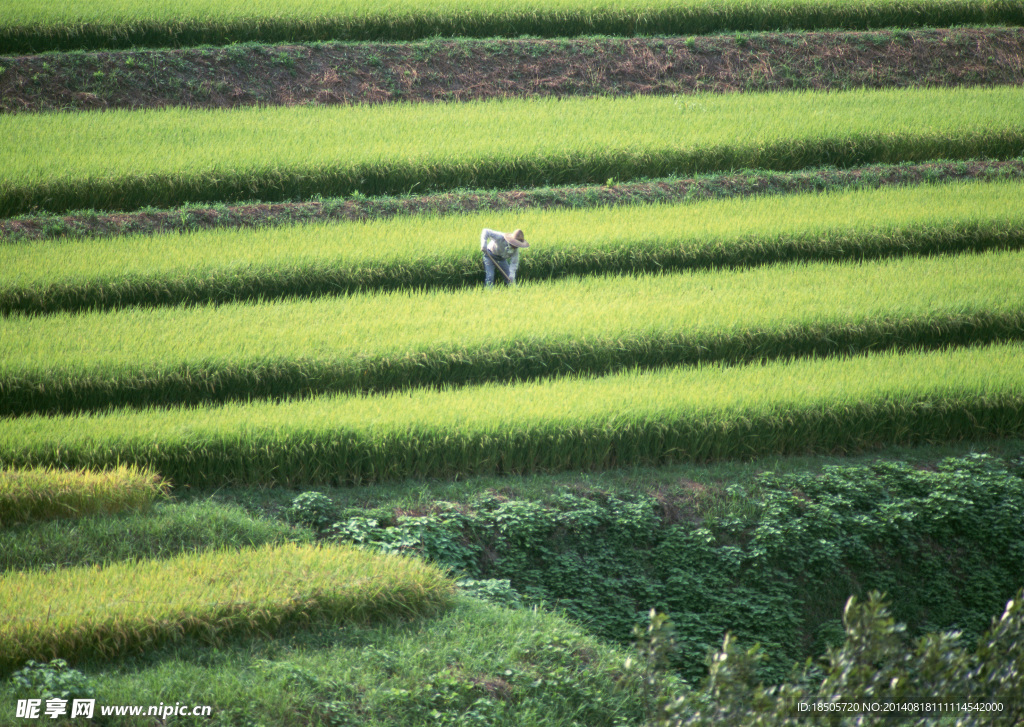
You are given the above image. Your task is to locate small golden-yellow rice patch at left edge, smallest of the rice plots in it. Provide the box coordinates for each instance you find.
[0,466,168,527]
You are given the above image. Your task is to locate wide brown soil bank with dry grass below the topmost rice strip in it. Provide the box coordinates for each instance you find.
[0,28,1024,113]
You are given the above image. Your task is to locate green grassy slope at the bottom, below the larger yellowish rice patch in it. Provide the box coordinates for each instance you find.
[0,598,643,727]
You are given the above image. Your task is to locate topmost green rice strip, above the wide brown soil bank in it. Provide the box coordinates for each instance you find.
[0,0,1024,53]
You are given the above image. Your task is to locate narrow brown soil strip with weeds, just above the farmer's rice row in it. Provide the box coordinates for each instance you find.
[0,159,1024,243]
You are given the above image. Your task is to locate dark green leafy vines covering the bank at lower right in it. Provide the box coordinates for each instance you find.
[301,455,1024,681]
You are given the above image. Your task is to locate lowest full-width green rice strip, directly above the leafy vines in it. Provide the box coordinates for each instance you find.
[0,343,1024,485]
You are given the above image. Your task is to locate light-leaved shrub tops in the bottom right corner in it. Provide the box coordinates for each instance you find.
[637,589,1024,727]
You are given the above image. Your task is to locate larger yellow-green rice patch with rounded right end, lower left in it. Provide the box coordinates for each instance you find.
[0,544,455,672]
